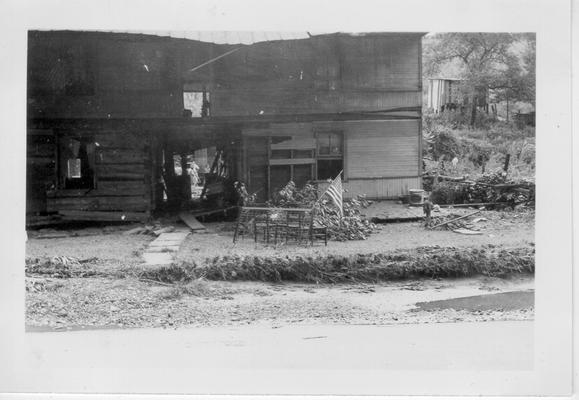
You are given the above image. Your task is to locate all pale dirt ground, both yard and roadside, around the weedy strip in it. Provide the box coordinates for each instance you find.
[26,211,534,329]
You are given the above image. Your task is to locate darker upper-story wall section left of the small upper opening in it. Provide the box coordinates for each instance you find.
[28,31,212,118]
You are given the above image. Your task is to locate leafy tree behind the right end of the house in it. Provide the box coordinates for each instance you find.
[424,33,535,126]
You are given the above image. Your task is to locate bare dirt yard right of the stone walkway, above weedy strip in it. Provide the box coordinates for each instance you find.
[176,211,535,261]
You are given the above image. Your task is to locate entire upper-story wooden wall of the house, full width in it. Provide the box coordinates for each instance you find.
[28,31,421,118]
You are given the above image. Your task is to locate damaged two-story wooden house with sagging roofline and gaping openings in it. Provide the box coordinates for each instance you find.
[27,31,422,220]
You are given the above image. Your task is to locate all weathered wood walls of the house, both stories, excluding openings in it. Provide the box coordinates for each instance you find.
[27,31,421,212]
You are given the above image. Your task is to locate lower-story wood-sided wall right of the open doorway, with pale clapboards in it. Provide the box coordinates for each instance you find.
[242,119,421,198]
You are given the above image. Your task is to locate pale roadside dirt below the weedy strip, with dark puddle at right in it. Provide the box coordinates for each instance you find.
[26,276,533,330]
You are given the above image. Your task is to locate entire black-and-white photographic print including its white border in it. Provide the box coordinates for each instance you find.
[0,1,572,396]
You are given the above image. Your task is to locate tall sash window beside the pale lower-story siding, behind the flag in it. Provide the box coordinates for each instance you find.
[316,132,344,180]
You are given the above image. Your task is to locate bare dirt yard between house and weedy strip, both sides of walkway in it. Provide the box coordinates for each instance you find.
[26,211,535,264]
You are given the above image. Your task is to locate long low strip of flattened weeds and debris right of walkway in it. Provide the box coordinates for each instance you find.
[184,245,535,283]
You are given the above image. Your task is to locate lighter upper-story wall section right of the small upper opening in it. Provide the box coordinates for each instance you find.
[193,34,422,116]
